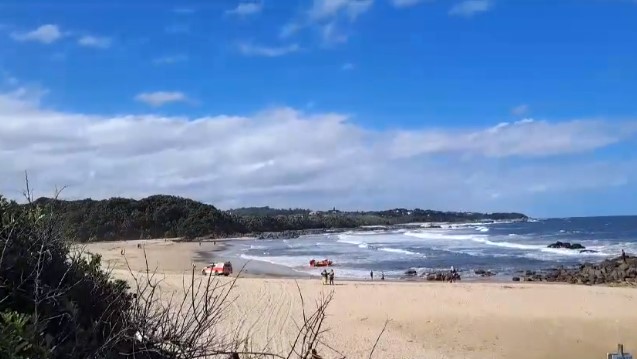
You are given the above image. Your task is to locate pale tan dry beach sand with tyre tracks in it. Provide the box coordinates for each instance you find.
[88,240,637,359]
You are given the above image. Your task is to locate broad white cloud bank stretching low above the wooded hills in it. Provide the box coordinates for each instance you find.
[0,91,637,211]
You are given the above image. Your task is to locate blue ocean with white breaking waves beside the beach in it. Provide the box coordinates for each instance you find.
[220,216,637,279]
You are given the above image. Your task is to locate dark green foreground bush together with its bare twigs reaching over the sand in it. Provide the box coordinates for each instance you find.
[0,193,358,359]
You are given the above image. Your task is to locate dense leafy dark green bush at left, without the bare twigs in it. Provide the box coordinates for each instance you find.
[0,197,132,358]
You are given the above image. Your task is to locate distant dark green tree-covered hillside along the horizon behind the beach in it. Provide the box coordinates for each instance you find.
[24,195,527,242]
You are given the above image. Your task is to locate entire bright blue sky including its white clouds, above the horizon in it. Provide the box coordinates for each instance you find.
[0,0,637,216]
